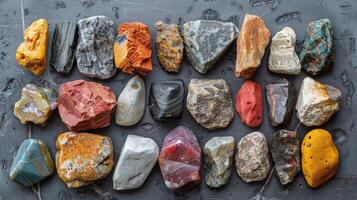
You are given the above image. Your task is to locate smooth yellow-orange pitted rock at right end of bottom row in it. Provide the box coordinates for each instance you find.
[301,129,340,188]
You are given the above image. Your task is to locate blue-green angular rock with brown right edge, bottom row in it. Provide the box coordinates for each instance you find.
[10,139,54,187]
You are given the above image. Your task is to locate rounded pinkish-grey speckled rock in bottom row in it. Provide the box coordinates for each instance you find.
[235,132,270,183]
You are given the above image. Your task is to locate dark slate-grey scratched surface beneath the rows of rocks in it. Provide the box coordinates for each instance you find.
[0,0,357,200]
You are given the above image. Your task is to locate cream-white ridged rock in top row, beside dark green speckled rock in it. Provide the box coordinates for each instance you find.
[269,27,301,75]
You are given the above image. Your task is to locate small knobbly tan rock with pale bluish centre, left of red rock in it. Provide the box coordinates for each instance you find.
[14,84,57,125]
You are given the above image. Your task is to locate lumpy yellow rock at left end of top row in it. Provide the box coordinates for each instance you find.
[16,19,48,76]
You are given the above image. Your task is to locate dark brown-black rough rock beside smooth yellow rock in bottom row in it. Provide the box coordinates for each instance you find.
[270,129,300,185]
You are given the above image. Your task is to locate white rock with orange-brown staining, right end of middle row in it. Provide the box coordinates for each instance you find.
[296,77,342,126]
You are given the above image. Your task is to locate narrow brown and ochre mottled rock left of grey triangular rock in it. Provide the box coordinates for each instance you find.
[155,21,184,72]
